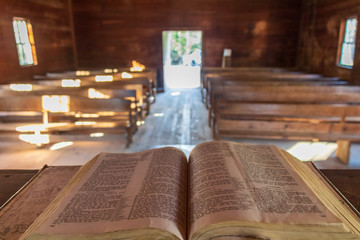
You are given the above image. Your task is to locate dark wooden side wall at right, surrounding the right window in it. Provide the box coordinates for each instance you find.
[298,0,360,84]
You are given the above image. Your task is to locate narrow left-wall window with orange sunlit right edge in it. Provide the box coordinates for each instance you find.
[13,18,37,66]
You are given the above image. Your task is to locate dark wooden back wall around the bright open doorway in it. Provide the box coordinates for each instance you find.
[73,0,301,88]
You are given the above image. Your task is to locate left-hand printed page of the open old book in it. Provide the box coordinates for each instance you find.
[23,148,187,239]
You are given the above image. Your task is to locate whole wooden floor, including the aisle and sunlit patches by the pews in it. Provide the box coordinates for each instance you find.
[0,89,360,169]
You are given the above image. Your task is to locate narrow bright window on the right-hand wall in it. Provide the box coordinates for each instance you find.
[339,17,357,68]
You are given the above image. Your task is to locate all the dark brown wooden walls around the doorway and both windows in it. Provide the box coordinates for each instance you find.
[0,0,360,84]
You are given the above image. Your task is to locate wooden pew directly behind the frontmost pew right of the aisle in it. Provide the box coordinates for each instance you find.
[209,84,360,125]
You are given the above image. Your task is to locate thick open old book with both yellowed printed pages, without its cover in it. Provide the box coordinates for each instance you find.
[21,141,360,240]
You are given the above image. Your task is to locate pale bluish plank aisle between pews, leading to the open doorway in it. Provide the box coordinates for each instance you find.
[126,88,212,155]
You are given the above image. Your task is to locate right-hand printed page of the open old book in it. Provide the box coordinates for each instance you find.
[188,142,340,236]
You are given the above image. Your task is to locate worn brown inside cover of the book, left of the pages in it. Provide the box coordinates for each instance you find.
[0,166,80,240]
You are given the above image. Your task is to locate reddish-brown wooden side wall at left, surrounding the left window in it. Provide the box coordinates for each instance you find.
[0,0,74,83]
